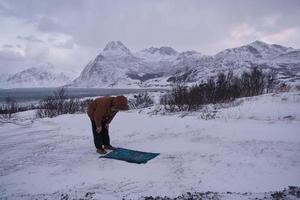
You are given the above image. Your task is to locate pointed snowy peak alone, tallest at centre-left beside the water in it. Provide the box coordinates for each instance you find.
[72,41,144,87]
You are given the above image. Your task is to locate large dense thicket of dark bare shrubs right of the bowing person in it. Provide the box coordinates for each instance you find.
[160,67,276,112]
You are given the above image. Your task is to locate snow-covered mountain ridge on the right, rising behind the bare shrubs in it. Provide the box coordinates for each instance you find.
[169,41,300,82]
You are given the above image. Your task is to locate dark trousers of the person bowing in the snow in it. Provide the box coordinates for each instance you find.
[91,120,110,149]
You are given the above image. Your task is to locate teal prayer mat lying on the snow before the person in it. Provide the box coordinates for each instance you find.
[100,148,159,164]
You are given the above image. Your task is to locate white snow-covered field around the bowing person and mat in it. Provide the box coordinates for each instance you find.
[0,92,300,200]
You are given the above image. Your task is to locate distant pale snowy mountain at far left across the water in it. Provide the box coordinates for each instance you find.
[4,63,70,88]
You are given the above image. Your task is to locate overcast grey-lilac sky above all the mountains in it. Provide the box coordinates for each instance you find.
[0,0,300,76]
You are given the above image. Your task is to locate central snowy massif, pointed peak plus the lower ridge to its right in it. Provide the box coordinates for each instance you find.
[71,41,202,87]
